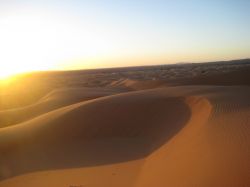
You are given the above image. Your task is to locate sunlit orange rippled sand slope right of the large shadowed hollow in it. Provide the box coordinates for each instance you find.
[137,87,250,187]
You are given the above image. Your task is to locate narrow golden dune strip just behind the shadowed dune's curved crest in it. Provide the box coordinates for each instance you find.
[0,88,121,128]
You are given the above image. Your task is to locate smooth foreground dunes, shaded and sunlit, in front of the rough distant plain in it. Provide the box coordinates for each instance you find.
[0,85,250,187]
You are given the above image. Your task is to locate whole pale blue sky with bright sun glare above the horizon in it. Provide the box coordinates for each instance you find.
[0,0,250,77]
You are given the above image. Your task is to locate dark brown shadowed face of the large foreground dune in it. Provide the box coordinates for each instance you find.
[0,90,190,179]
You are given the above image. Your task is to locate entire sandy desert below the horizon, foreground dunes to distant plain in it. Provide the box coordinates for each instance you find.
[0,59,250,187]
